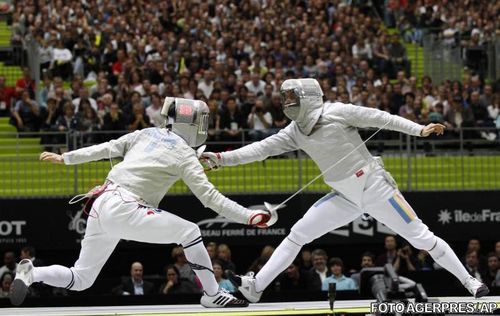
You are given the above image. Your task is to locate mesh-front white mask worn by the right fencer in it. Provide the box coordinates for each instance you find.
[280,78,323,135]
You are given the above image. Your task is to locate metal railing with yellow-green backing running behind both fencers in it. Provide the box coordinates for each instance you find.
[0,128,500,197]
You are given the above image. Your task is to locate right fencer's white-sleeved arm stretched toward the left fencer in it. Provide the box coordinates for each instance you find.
[220,123,298,166]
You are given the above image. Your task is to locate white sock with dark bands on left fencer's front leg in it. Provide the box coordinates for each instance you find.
[184,242,219,296]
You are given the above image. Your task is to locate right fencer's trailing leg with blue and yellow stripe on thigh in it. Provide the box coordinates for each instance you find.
[363,171,469,283]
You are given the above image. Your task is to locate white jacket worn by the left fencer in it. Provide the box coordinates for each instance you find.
[62,127,251,224]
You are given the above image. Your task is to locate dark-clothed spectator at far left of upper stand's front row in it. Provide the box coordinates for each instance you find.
[11,90,43,132]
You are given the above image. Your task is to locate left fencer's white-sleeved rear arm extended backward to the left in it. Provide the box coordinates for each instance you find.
[62,131,140,165]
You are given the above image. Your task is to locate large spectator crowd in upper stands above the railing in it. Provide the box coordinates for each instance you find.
[0,0,500,152]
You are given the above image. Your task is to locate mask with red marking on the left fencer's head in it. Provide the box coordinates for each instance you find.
[161,97,209,147]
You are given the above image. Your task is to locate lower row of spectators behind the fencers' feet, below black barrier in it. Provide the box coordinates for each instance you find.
[0,235,500,297]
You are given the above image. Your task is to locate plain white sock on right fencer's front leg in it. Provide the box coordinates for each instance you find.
[255,237,302,292]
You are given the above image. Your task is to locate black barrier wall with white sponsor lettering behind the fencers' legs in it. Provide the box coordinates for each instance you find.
[0,191,500,250]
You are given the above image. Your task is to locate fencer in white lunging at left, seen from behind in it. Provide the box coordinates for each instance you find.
[10,98,269,307]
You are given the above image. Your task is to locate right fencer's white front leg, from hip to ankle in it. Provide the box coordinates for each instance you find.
[255,192,361,292]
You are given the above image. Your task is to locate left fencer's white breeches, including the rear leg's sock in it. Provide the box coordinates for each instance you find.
[34,184,204,291]
